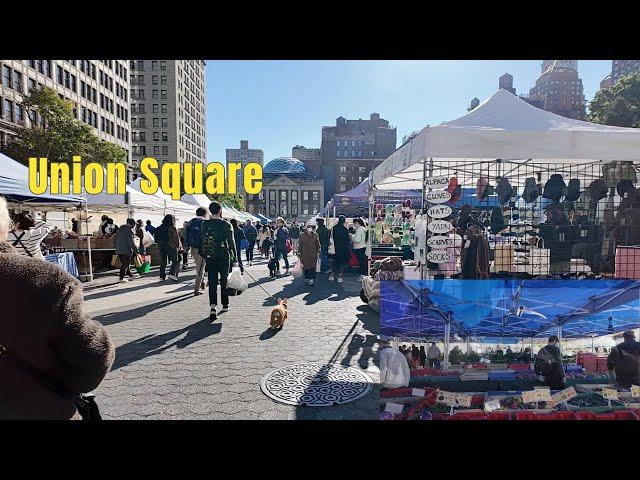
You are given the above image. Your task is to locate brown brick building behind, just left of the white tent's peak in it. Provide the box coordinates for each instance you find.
[320,113,397,199]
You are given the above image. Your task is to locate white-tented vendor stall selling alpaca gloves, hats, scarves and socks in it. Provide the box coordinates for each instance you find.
[370,90,640,279]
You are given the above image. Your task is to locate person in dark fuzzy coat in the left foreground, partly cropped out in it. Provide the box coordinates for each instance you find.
[0,197,115,420]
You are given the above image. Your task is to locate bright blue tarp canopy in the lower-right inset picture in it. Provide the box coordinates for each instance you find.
[381,279,640,338]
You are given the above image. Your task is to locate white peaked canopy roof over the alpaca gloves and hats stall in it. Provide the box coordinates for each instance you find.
[371,89,640,190]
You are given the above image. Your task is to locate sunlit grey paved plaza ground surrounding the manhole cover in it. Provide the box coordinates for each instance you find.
[85,257,379,419]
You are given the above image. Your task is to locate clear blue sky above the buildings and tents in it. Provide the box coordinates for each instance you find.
[206,60,611,162]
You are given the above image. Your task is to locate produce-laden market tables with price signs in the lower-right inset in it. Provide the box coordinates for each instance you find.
[380,364,640,420]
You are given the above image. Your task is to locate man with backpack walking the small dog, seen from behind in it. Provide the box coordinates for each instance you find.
[196,202,236,321]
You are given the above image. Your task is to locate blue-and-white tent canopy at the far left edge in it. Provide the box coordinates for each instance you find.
[0,153,84,206]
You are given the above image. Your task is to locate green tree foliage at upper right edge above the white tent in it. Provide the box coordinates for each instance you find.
[587,73,640,128]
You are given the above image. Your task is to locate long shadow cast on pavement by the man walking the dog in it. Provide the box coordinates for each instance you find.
[111,317,222,371]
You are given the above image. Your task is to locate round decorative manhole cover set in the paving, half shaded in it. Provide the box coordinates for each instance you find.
[260,363,373,407]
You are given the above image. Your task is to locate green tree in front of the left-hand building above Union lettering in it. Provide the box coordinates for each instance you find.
[4,87,127,165]
